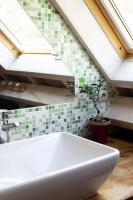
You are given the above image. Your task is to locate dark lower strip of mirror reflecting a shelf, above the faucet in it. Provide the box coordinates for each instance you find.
[0,73,74,110]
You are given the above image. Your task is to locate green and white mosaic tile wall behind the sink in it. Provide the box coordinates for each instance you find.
[6,0,112,140]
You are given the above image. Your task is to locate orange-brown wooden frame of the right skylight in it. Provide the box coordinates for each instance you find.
[84,0,133,59]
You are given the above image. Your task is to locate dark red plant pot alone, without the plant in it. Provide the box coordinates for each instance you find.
[89,118,111,144]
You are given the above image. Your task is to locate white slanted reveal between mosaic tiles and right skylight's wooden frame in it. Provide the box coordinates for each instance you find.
[50,0,122,79]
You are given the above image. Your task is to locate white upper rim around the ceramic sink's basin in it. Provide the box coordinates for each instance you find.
[0,132,120,192]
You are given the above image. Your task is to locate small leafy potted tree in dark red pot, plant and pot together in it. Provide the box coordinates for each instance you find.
[80,78,111,144]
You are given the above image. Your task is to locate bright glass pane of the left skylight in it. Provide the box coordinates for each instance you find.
[0,0,52,52]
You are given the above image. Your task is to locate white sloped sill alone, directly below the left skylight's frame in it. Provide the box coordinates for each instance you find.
[7,54,73,77]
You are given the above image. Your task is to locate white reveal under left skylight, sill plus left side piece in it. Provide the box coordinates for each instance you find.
[0,42,74,81]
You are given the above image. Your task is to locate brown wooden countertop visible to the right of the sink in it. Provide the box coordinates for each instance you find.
[86,137,133,200]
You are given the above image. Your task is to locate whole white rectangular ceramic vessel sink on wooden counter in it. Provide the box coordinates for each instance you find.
[0,133,119,200]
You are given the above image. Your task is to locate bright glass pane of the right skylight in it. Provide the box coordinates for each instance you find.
[100,0,133,49]
